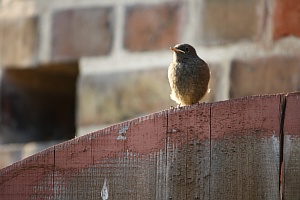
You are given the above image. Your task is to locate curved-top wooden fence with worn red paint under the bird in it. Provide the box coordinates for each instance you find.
[0,93,300,200]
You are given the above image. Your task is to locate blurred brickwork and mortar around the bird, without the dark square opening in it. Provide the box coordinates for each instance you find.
[0,0,300,166]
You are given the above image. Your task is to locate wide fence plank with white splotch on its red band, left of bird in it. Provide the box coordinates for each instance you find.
[54,112,167,199]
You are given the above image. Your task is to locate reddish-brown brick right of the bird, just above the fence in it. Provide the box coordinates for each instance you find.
[230,56,300,98]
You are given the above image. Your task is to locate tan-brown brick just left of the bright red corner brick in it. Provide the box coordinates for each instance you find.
[198,0,258,45]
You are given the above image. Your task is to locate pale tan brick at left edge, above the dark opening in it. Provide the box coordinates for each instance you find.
[0,16,38,65]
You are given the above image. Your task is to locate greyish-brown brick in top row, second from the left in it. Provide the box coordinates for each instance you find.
[52,7,113,60]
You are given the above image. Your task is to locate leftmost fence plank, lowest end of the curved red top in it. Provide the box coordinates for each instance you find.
[0,147,54,200]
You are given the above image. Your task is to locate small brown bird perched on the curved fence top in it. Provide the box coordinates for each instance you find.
[168,44,210,106]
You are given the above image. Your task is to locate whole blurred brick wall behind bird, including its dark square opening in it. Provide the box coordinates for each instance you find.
[0,0,300,168]
